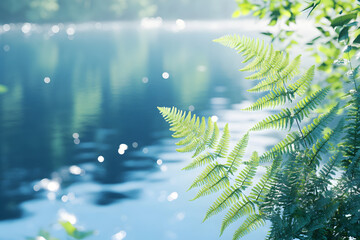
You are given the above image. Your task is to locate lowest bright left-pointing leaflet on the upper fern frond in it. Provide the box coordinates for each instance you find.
[250,108,293,131]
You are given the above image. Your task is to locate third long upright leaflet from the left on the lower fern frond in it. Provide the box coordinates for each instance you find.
[235,152,259,191]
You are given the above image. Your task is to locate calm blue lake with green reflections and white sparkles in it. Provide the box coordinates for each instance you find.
[0,19,273,240]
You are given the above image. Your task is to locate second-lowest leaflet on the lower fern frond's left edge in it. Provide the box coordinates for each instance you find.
[220,195,255,235]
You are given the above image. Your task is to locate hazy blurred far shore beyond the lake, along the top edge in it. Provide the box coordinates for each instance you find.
[0,0,236,23]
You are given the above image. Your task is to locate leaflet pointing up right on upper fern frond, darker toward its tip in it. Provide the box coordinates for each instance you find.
[292,87,329,121]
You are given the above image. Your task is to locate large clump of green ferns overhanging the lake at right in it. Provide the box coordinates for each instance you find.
[159,32,360,240]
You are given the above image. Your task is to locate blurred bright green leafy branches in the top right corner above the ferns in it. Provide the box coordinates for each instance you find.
[233,0,360,109]
